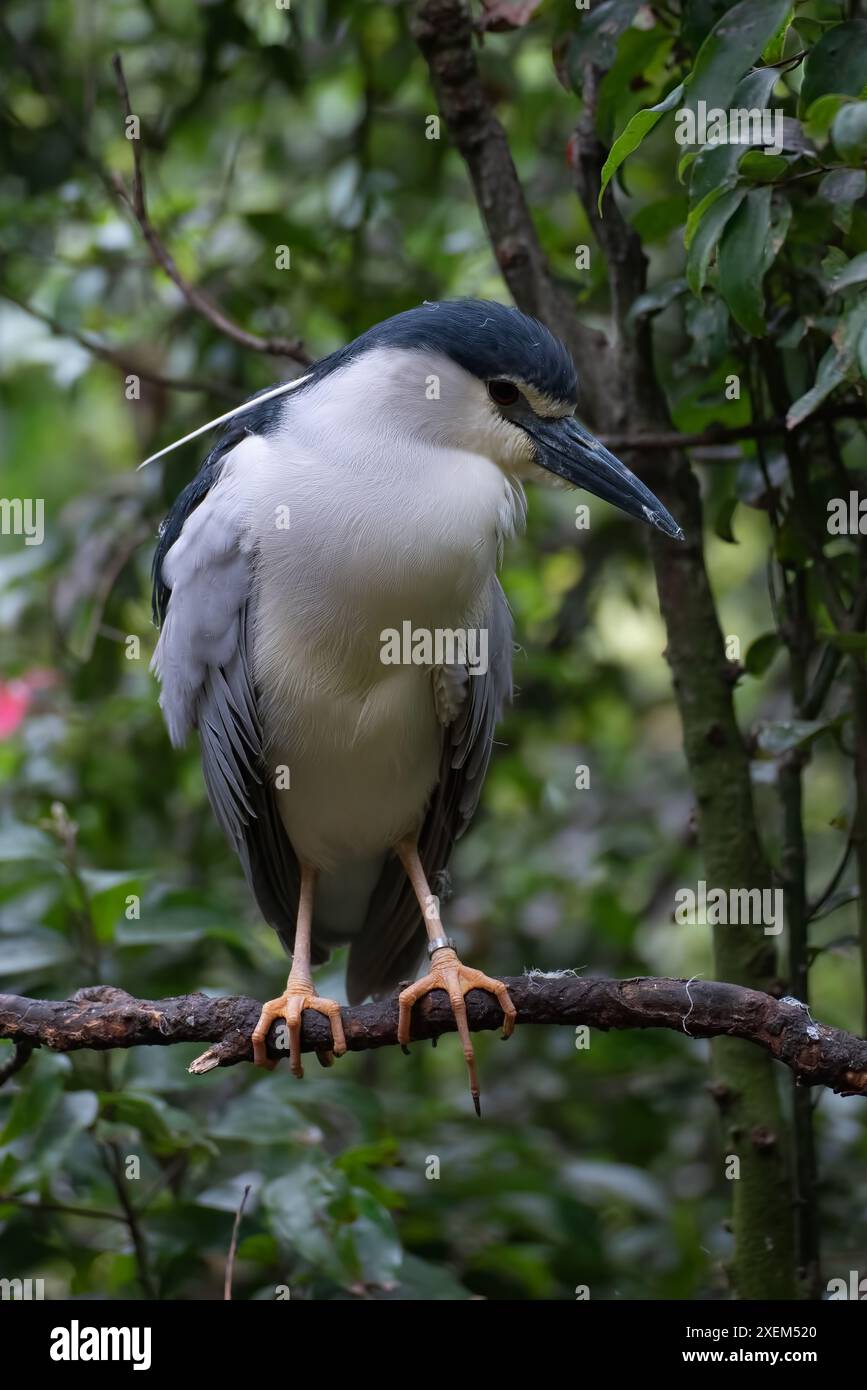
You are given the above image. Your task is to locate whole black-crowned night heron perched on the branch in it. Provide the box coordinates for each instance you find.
[146,299,682,1113]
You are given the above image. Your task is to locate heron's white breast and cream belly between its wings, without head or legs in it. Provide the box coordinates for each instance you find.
[245,369,515,869]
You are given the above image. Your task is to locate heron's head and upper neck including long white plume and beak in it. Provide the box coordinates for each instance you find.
[140,299,684,539]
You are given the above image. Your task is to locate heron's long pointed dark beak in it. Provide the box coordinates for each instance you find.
[525,416,684,541]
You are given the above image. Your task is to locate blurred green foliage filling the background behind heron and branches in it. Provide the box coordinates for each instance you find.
[0,0,867,1300]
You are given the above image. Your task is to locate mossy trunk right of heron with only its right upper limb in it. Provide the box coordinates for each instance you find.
[572,67,798,1300]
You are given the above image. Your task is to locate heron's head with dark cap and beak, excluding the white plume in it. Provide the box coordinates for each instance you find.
[322,300,682,539]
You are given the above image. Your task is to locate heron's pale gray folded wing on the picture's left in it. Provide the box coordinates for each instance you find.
[153,461,307,960]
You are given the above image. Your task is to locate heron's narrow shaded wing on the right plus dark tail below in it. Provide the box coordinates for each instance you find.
[346,578,511,1004]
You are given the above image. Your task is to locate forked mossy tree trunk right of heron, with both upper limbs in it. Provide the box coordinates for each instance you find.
[414,0,795,1298]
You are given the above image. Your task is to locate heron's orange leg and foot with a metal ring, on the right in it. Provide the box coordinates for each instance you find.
[396,840,517,1115]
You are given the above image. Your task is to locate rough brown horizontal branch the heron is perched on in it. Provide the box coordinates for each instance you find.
[0,972,867,1097]
